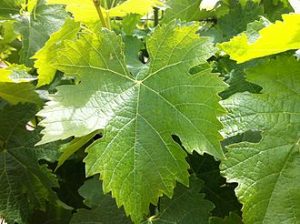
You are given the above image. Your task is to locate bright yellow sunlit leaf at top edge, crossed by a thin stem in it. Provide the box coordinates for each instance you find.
[47,0,162,23]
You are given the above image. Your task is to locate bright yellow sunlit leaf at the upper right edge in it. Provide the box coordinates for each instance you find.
[219,14,300,63]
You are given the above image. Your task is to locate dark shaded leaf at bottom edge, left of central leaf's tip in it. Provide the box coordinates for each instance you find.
[71,176,131,224]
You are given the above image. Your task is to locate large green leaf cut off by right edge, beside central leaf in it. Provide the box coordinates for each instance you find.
[221,56,300,224]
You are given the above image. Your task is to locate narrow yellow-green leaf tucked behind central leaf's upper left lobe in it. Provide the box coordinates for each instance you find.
[33,19,80,87]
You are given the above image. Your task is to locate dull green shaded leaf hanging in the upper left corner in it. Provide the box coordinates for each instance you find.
[16,0,67,66]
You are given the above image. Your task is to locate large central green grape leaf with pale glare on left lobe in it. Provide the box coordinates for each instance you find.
[39,22,225,222]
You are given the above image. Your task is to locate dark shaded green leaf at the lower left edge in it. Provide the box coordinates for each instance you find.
[0,102,58,223]
